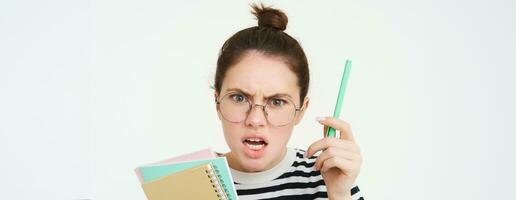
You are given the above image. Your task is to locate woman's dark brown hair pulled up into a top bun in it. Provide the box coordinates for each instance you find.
[214,4,310,104]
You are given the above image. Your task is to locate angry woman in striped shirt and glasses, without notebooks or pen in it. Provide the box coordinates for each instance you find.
[214,5,363,200]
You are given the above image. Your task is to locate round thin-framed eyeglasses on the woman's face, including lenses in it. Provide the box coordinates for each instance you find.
[215,92,301,126]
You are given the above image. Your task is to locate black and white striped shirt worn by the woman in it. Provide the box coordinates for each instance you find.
[231,148,364,200]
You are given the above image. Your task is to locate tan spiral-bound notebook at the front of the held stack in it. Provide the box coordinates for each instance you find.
[142,164,227,200]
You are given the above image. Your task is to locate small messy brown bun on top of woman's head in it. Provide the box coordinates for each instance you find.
[251,4,288,31]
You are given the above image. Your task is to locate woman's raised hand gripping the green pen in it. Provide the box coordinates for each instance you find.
[305,117,362,200]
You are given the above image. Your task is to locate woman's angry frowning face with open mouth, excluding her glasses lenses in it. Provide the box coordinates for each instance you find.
[215,51,308,172]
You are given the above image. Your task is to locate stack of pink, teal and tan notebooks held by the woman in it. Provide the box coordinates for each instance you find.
[135,149,237,200]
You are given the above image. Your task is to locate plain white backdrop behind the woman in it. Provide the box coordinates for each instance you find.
[0,0,516,200]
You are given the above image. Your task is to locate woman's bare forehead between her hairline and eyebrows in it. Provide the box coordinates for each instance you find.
[221,51,299,99]
